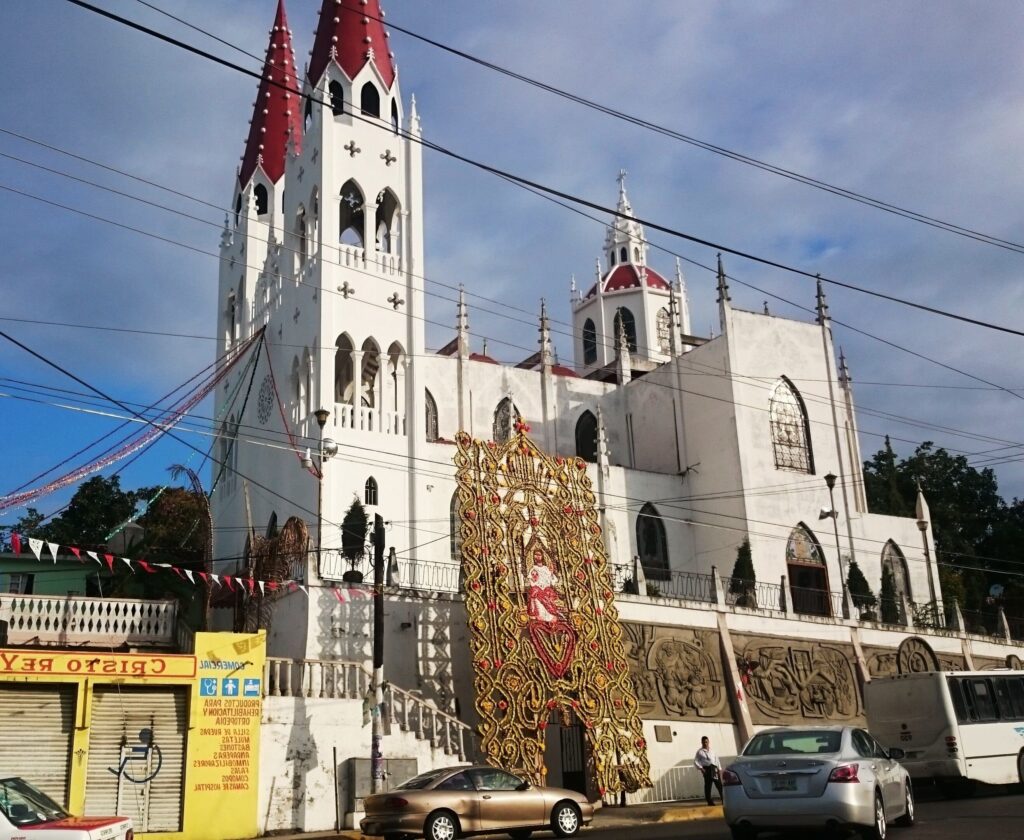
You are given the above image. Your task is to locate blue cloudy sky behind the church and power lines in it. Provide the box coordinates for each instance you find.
[0,0,1024,536]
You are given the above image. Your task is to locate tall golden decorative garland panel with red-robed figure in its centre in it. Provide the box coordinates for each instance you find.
[456,422,650,796]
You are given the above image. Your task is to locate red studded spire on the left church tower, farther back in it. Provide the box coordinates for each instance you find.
[239,0,302,185]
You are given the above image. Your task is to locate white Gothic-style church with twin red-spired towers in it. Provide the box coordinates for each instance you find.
[201,0,1015,827]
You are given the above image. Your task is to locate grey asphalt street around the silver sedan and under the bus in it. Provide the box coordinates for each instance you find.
[585,792,1024,840]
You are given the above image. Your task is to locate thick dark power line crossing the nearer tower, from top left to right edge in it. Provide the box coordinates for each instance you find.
[54,0,1024,337]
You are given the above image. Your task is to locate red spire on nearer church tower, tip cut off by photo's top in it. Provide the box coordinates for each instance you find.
[309,0,394,90]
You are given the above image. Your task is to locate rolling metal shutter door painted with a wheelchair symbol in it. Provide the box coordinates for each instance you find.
[85,686,188,832]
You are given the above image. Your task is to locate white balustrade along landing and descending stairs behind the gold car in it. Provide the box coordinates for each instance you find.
[263,657,473,761]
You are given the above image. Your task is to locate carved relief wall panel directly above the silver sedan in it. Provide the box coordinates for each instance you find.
[732,634,864,725]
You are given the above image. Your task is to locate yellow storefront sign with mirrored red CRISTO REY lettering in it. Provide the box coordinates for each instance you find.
[0,650,196,679]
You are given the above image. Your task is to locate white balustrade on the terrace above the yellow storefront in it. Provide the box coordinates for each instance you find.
[0,595,178,647]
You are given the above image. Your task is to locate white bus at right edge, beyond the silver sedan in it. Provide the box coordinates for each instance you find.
[864,671,1024,794]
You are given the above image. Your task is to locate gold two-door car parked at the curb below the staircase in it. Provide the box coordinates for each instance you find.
[359,764,594,840]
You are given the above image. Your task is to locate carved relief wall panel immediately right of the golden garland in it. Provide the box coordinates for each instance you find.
[623,623,732,723]
